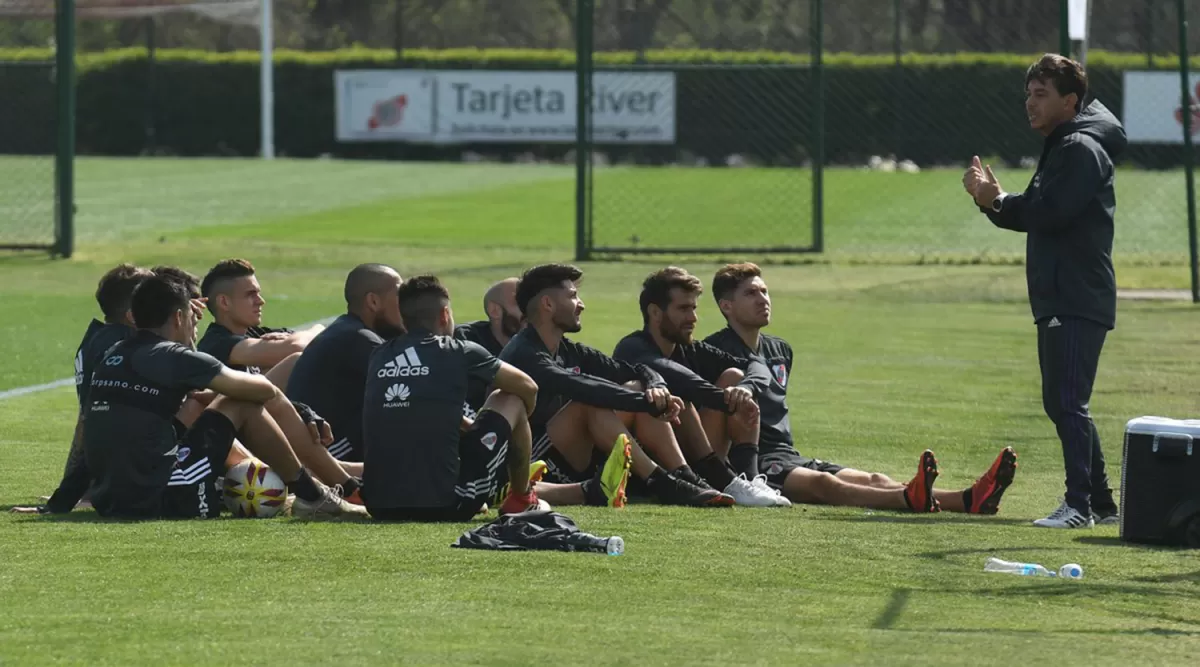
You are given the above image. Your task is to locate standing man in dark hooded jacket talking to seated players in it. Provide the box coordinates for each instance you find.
[962,54,1126,528]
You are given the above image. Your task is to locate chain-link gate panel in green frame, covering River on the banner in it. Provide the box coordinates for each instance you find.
[580,0,822,253]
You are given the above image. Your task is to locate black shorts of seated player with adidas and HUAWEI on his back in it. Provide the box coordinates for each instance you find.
[367,410,512,522]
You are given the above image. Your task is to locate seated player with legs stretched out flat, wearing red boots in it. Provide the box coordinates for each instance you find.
[706,263,1016,515]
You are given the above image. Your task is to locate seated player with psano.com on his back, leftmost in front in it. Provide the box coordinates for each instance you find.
[18,276,364,518]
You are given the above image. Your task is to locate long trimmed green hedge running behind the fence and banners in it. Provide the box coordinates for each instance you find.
[0,48,1200,166]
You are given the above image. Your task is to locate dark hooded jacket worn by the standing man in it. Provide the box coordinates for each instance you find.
[985,102,1126,329]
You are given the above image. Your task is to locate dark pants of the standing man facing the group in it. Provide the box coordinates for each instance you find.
[1038,318,1114,516]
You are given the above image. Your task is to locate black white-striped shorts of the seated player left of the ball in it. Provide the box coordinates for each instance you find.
[162,410,238,518]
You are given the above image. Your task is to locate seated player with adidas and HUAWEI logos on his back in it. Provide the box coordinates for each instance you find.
[362,276,546,521]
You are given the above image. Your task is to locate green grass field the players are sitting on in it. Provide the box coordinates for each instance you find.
[0,160,1200,665]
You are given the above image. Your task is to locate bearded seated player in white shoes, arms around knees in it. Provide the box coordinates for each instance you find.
[612,266,791,507]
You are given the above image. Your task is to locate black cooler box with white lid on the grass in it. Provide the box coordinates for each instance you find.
[1121,416,1200,547]
